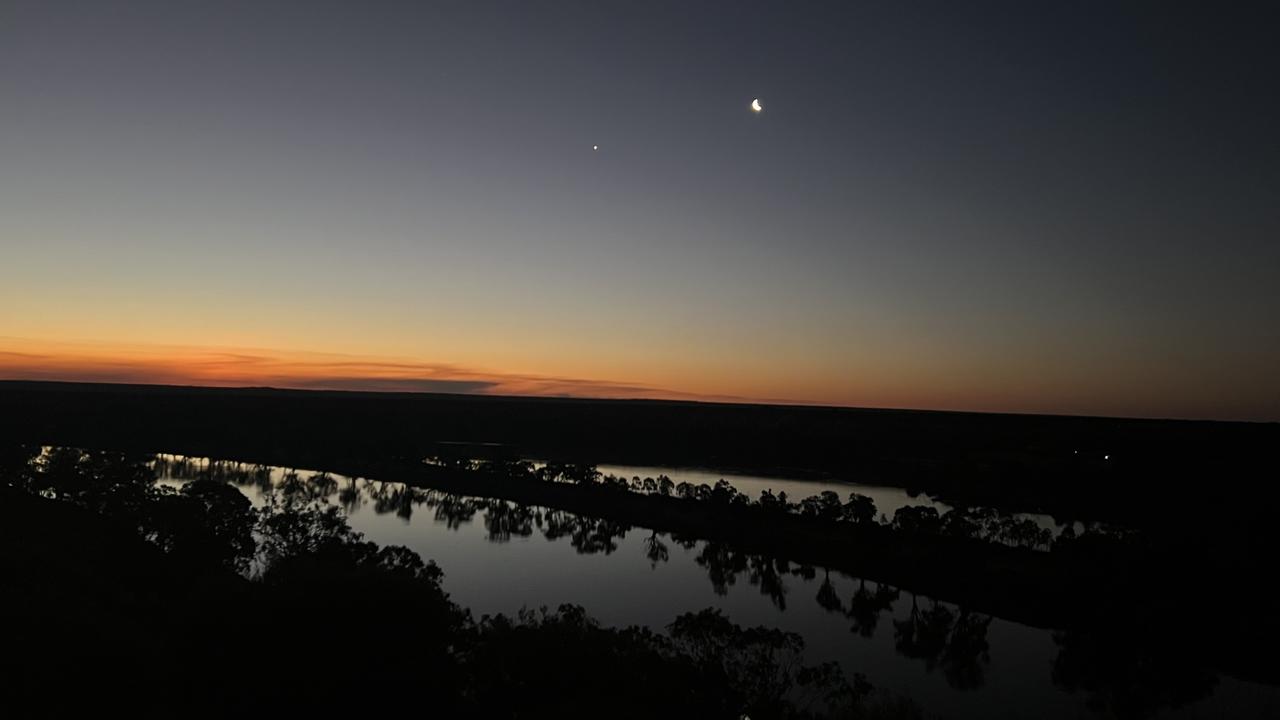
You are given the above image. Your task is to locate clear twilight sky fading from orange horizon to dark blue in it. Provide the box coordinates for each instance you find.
[0,0,1280,420]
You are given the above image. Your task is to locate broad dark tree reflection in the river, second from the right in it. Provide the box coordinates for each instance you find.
[893,596,991,691]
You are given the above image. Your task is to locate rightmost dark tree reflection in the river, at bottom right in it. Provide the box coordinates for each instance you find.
[1052,628,1217,719]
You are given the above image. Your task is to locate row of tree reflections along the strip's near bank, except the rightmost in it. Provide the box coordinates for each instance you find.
[154,456,992,689]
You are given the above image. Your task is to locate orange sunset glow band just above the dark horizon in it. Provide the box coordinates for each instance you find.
[0,336,1275,421]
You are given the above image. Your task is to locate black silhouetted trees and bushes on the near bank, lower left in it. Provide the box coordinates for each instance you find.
[0,447,915,717]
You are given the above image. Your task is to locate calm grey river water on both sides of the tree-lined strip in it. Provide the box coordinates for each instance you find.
[157,456,1280,719]
